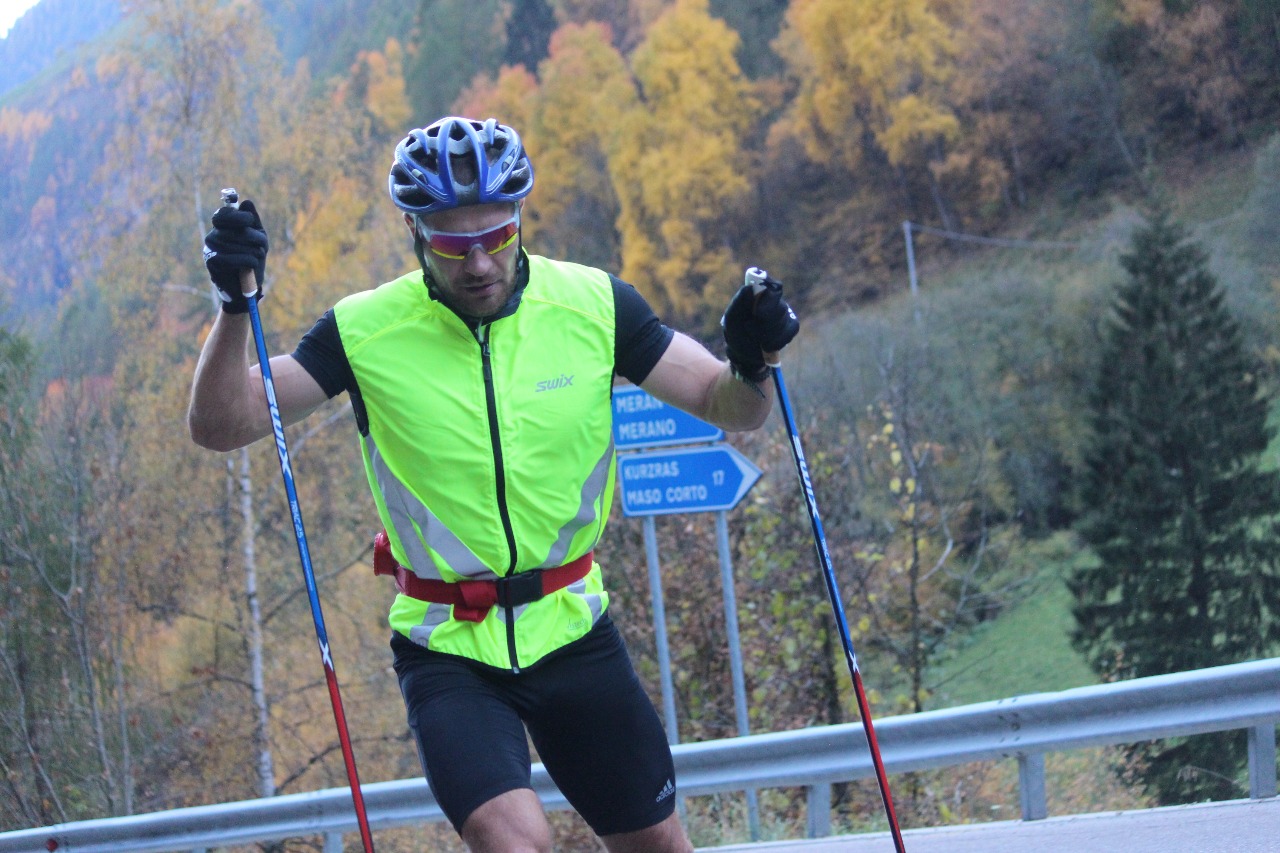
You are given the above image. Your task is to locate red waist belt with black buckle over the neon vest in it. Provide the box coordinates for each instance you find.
[374,530,593,622]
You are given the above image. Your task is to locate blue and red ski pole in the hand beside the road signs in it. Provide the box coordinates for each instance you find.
[746,266,906,853]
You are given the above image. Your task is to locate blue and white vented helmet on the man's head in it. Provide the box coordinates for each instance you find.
[387,115,534,216]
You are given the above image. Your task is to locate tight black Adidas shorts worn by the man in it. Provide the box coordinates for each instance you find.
[392,613,676,835]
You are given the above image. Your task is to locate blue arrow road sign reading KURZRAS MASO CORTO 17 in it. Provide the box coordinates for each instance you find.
[618,444,760,516]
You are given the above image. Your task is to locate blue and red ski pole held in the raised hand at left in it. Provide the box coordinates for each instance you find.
[223,187,374,853]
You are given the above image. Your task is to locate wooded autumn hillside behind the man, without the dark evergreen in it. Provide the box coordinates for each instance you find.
[0,0,1280,835]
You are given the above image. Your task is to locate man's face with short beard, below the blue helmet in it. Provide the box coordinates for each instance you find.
[404,202,520,318]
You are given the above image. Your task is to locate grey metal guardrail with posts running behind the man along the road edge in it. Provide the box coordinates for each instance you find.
[0,658,1280,853]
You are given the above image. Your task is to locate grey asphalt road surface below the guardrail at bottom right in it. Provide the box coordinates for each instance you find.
[700,797,1280,853]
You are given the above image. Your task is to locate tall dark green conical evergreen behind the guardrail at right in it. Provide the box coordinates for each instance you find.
[1071,207,1280,803]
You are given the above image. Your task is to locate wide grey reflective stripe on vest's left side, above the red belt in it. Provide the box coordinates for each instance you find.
[364,435,498,580]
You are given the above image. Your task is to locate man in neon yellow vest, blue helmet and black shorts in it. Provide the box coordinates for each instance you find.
[188,118,799,853]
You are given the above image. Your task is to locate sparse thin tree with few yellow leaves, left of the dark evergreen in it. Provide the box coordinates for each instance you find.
[842,342,1027,713]
